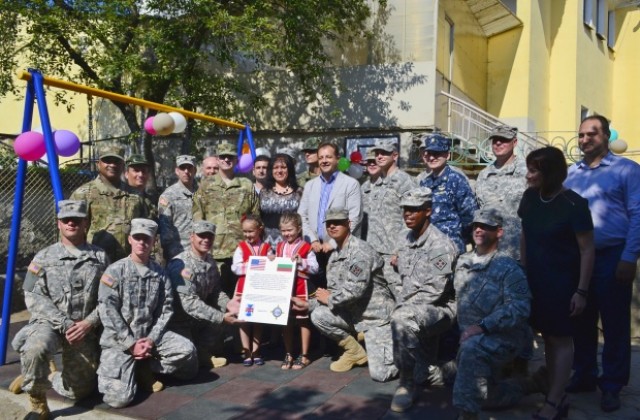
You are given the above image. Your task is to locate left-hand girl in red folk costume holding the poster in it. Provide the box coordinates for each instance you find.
[231,214,272,367]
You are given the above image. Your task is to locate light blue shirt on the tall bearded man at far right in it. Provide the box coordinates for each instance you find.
[564,152,640,263]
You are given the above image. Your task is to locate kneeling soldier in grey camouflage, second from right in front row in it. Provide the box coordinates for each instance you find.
[391,188,458,412]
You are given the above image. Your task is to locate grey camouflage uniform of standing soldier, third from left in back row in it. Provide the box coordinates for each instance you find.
[158,181,197,261]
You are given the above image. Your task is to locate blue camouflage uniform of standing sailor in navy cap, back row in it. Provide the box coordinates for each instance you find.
[420,165,478,252]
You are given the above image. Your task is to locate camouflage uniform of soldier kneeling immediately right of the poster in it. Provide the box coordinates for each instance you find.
[310,235,397,381]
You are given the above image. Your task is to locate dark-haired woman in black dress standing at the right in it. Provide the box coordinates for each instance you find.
[518,146,594,419]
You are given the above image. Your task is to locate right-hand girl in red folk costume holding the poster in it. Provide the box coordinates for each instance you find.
[276,212,318,370]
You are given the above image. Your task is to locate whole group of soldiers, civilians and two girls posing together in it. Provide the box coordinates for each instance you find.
[10,116,640,419]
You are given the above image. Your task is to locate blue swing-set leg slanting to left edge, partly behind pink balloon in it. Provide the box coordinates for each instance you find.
[0,77,34,366]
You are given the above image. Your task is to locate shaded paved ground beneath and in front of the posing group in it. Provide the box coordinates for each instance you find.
[0,316,640,420]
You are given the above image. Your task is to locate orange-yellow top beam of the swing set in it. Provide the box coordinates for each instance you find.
[18,71,244,130]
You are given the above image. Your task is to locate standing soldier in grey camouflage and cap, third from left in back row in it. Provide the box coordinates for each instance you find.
[158,155,198,262]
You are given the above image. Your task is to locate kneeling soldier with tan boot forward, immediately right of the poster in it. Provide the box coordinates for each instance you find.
[309,209,397,381]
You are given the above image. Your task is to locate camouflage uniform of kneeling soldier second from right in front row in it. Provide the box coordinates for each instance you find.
[391,224,458,377]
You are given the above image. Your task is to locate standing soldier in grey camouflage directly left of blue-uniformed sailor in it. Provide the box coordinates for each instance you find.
[363,140,416,300]
